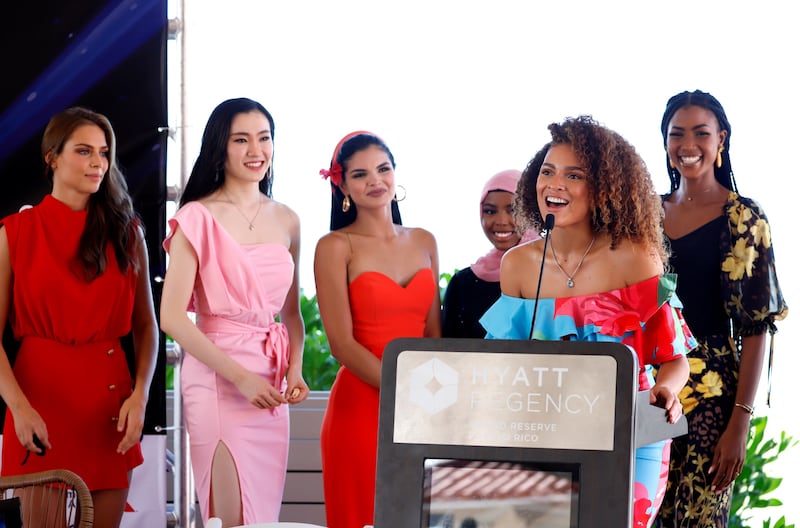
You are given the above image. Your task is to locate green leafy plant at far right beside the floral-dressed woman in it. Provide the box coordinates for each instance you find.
[728,416,797,528]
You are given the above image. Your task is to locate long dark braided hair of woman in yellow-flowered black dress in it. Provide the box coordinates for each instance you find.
[661,90,738,192]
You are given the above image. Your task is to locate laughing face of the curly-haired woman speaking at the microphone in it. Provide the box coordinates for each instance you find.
[536,143,591,226]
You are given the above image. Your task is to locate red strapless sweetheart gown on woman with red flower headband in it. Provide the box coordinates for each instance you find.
[320,268,438,528]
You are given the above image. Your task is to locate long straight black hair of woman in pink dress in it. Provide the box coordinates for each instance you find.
[180,97,275,206]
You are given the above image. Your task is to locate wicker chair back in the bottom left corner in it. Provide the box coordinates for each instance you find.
[0,469,94,528]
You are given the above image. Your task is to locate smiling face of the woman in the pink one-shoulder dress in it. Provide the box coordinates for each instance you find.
[225,111,272,182]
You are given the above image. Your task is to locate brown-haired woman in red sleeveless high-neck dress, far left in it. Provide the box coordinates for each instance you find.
[0,108,158,527]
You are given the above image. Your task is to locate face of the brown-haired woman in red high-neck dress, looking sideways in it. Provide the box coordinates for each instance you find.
[47,124,109,201]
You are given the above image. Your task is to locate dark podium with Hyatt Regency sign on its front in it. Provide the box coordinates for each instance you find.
[375,339,686,528]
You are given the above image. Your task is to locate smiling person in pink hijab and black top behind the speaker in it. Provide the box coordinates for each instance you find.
[442,170,522,339]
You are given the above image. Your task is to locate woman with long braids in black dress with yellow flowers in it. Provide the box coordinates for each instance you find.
[659,90,788,528]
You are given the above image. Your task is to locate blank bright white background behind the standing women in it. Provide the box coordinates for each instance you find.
[170,0,800,522]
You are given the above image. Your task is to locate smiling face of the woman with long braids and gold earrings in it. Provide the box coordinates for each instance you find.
[666,106,727,184]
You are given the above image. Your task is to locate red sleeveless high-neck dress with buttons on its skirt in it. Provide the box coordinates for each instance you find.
[2,195,143,490]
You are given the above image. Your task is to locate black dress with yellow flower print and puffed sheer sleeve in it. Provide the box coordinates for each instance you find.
[658,192,788,528]
